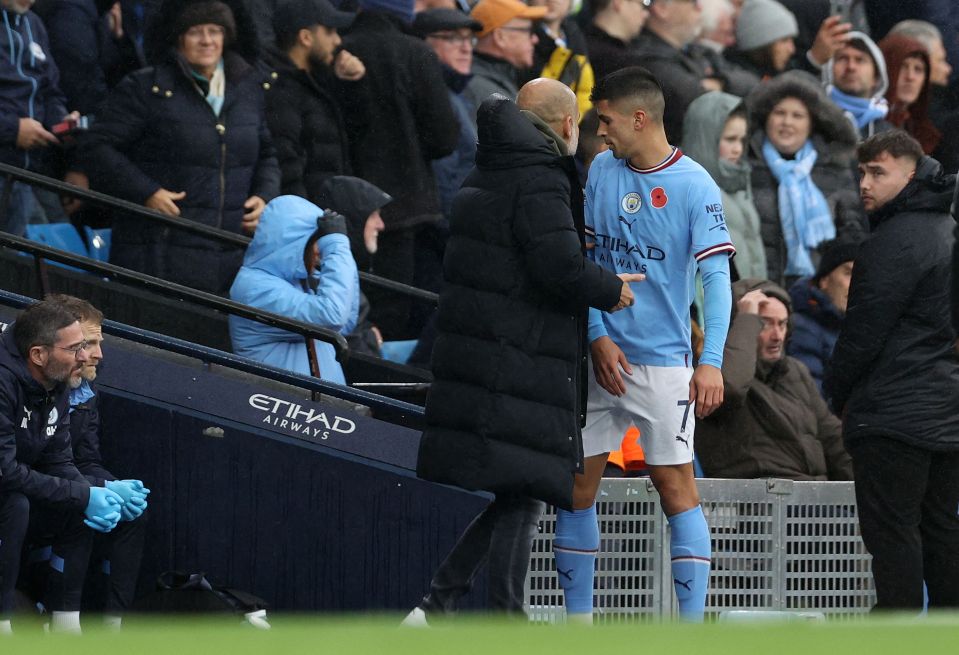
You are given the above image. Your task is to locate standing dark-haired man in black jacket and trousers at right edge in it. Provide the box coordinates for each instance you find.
[823,130,959,612]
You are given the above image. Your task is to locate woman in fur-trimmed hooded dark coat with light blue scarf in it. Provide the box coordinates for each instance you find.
[747,71,866,288]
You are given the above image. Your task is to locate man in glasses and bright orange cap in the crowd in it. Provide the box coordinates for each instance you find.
[465,0,546,116]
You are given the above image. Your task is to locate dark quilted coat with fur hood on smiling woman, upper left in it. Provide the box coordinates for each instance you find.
[81,2,280,293]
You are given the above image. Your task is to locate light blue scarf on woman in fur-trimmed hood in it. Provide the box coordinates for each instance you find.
[763,139,836,276]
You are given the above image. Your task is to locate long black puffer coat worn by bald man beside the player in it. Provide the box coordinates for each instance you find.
[417,95,622,508]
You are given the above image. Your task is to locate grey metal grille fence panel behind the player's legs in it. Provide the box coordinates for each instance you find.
[527,478,875,623]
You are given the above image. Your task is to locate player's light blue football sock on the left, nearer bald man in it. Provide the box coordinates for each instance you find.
[553,504,599,616]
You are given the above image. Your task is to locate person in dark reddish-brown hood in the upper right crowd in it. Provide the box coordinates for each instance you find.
[879,34,942,155]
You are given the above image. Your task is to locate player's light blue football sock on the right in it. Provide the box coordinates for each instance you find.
[667,505,711,623]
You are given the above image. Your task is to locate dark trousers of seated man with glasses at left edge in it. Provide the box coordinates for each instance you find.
[0,492,94,618]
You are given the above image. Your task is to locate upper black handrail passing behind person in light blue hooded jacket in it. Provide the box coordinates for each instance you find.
[0,163,439,305]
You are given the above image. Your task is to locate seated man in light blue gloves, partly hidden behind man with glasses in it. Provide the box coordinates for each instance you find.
[48,295,150,628]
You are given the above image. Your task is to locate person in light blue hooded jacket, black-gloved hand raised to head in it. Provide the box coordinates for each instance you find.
[230,196,360,384]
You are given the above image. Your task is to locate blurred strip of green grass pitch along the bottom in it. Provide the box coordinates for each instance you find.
[0,614,959,655]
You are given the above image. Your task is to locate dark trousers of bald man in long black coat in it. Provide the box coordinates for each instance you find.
[420,496,546,617]
